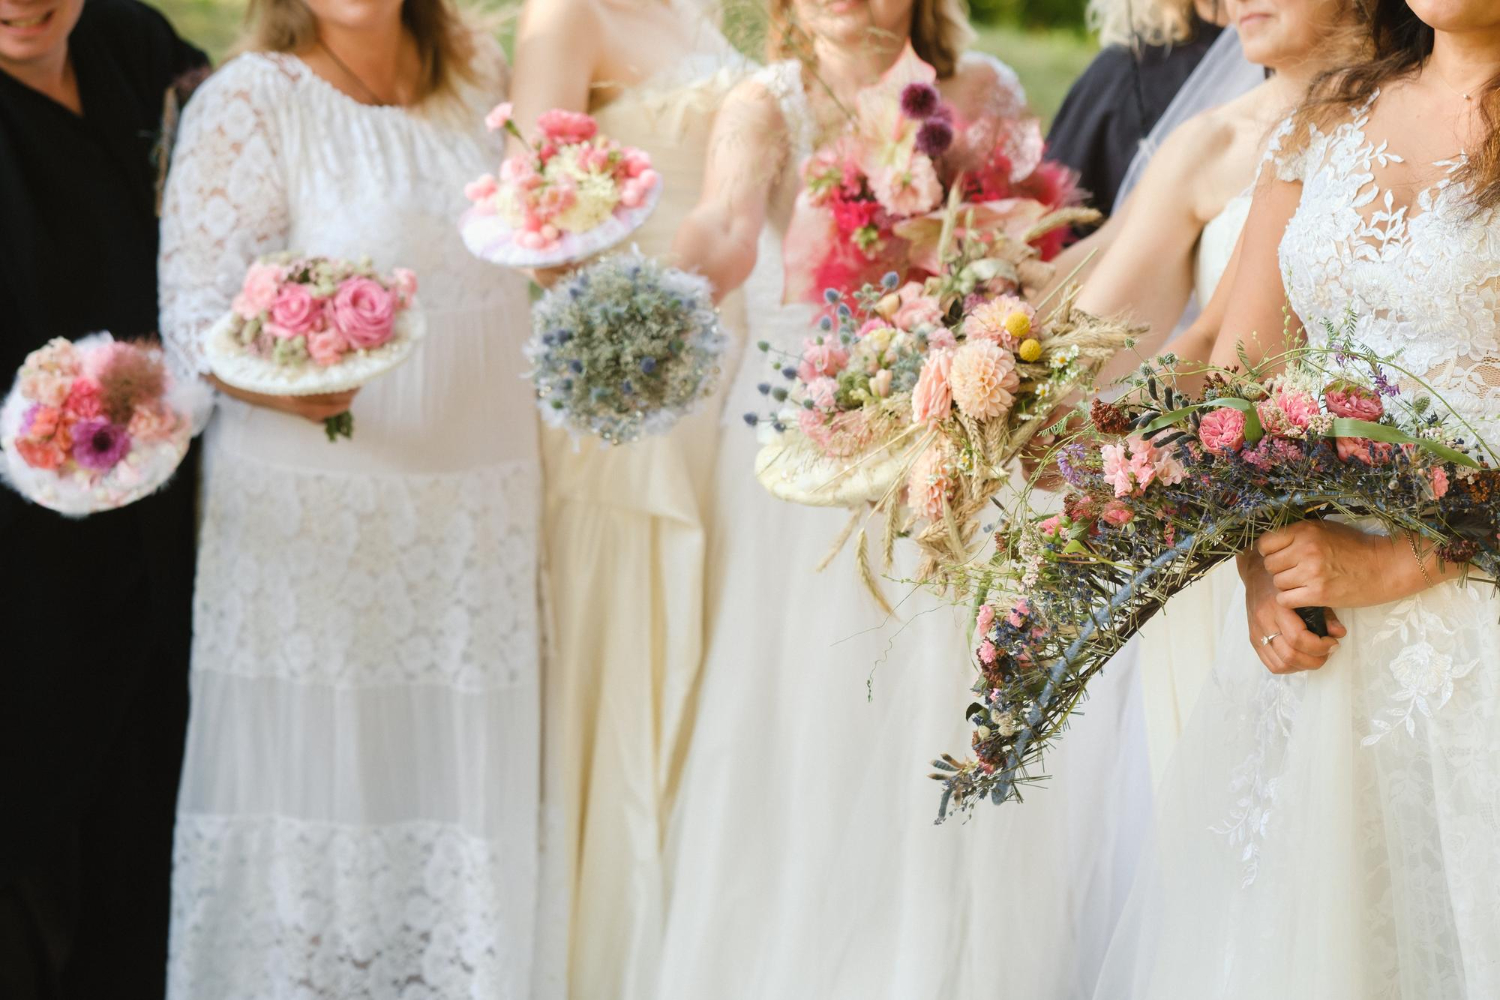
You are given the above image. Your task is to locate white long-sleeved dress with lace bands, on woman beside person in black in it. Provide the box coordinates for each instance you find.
[161,54,540,1000]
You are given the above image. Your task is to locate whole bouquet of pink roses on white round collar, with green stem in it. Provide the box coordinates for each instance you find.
[204,253,426,441]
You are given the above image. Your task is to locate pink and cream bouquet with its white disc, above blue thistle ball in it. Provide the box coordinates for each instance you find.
[459,103,662,268]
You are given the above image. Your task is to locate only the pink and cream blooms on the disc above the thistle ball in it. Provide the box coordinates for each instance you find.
[464,105,662,250]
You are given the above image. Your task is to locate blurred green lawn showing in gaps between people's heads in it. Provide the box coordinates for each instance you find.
[147,0,1095,121]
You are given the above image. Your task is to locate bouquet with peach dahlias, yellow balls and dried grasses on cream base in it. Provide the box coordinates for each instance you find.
[746,215,1136,602]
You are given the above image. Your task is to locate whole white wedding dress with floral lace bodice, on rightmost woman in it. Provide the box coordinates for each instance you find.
[1095,95,1500,1000]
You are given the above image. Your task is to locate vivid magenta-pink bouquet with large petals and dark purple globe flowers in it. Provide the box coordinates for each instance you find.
[785,46,1098,301]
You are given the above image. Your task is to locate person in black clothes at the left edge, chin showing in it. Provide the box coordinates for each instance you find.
[0,0,206,1000]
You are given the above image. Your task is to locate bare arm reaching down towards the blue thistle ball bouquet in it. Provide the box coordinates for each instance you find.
[672,81,789,298]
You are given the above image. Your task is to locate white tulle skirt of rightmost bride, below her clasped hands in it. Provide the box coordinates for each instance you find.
[1095,583,1500,1000]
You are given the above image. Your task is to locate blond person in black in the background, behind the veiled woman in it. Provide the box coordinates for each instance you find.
[1047,0,1223,214]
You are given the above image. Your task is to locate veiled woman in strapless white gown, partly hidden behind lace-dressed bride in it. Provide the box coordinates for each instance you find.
[1079,0,1358,780]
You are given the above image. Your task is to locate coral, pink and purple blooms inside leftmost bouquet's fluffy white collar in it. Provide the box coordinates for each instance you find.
[14,339,186,474]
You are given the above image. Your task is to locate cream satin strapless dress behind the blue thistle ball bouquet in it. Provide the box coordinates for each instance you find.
[539,3,750,1000]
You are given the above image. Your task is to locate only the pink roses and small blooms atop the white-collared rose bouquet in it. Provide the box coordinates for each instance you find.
[233,258,417,367]
